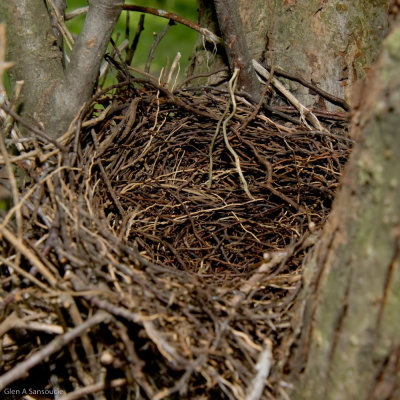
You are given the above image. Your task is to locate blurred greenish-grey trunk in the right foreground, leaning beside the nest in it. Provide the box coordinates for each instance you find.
[292,23,400,400]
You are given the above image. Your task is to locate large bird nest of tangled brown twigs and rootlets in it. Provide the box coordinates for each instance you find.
[0,73,351,399]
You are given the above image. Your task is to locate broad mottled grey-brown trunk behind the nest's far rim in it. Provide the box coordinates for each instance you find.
[189,0,387,109]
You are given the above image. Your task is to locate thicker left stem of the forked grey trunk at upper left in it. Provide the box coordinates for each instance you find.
[0,0,64,131]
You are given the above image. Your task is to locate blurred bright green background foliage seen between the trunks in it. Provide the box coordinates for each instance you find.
[67,0,197,79]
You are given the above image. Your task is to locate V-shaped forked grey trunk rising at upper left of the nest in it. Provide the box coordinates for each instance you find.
[0,0,124,138]
